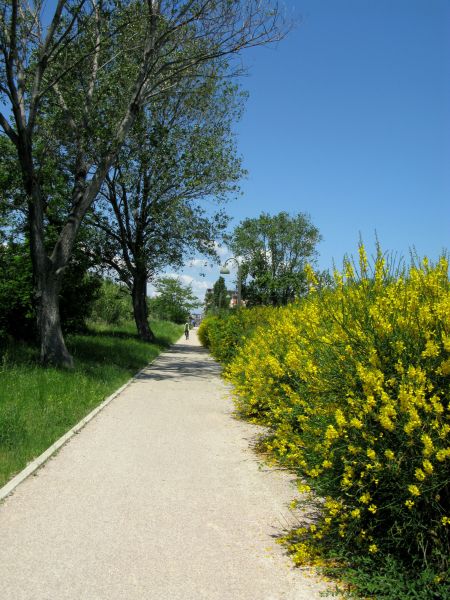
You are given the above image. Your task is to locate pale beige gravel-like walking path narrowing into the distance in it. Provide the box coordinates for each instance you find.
[0,334,325,600]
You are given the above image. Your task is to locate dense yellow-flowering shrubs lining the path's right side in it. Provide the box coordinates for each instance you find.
[200,247,450,577]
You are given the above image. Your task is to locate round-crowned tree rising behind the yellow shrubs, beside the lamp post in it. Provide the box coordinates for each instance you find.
[227,212,321,306]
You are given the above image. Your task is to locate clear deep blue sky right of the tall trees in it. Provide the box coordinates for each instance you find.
[179,0,450,297]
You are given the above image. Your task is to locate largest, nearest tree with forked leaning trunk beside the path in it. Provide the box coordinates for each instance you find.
[0,0,280,366]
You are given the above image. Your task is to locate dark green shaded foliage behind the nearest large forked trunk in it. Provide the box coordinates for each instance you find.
[0,137,100,341]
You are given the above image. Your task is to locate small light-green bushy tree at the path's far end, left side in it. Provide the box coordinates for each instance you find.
[149,277,201,323]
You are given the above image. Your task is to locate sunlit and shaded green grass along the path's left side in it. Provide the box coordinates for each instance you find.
[0,321,183,487]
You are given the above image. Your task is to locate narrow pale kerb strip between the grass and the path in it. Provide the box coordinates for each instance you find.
[0,336,183,502]
